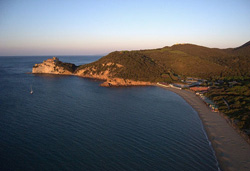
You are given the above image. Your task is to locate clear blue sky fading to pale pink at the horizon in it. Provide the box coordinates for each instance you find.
[0,0,250,56]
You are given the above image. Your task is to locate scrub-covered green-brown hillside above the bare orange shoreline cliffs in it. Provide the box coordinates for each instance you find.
[77,42,250,82]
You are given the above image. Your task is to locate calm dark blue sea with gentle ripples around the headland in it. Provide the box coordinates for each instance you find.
[0,56,218,171]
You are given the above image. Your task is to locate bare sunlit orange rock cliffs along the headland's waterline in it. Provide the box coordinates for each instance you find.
[32,57,152,87]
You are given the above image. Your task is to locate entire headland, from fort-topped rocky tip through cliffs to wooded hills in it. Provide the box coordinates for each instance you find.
[32,42,250,87]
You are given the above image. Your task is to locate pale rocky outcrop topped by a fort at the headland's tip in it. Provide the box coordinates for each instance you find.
[32,57,76,75]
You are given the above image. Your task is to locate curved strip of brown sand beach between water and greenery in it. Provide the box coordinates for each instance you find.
[159,87,250,171]
